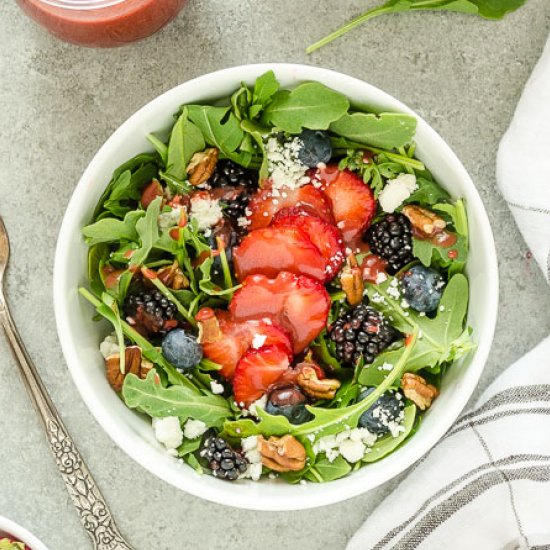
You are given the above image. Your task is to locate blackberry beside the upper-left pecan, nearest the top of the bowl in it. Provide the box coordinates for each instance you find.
[208,159,258,220]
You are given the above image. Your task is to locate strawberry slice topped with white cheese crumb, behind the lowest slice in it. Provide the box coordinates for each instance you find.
[202,311,292,380]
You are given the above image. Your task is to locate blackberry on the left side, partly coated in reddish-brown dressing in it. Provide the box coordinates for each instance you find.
[124,289,178,336]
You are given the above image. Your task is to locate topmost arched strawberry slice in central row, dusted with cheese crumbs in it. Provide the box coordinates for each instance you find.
[248,183,333,231]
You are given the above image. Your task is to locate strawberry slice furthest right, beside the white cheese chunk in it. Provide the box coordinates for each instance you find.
[313,164,376,247]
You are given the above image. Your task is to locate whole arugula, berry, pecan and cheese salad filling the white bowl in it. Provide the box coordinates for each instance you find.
[79,71,476,484]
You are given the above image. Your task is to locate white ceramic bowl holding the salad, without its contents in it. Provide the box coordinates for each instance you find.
[53,64,498,510]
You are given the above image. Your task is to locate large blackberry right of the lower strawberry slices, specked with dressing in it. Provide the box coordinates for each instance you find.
[329,303,398,366]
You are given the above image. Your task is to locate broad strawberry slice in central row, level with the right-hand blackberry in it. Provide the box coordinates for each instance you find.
[233,227,327,281]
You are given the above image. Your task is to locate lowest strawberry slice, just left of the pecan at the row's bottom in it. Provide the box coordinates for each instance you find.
[233,346,292,407]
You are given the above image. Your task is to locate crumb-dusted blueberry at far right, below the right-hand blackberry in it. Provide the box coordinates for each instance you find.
[401,264,445,313]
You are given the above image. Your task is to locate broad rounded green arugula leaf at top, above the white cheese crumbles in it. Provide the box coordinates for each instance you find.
[262,82,349,134]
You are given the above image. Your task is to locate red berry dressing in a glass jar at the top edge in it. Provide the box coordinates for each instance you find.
[17,0,187,48]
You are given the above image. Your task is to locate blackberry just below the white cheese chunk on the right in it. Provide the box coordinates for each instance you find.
[364,214,414,275]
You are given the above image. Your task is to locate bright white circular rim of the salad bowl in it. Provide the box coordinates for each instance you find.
[53,63,499,511]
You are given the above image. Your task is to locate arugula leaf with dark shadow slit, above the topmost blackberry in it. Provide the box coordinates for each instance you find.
[187,105,244,158]
